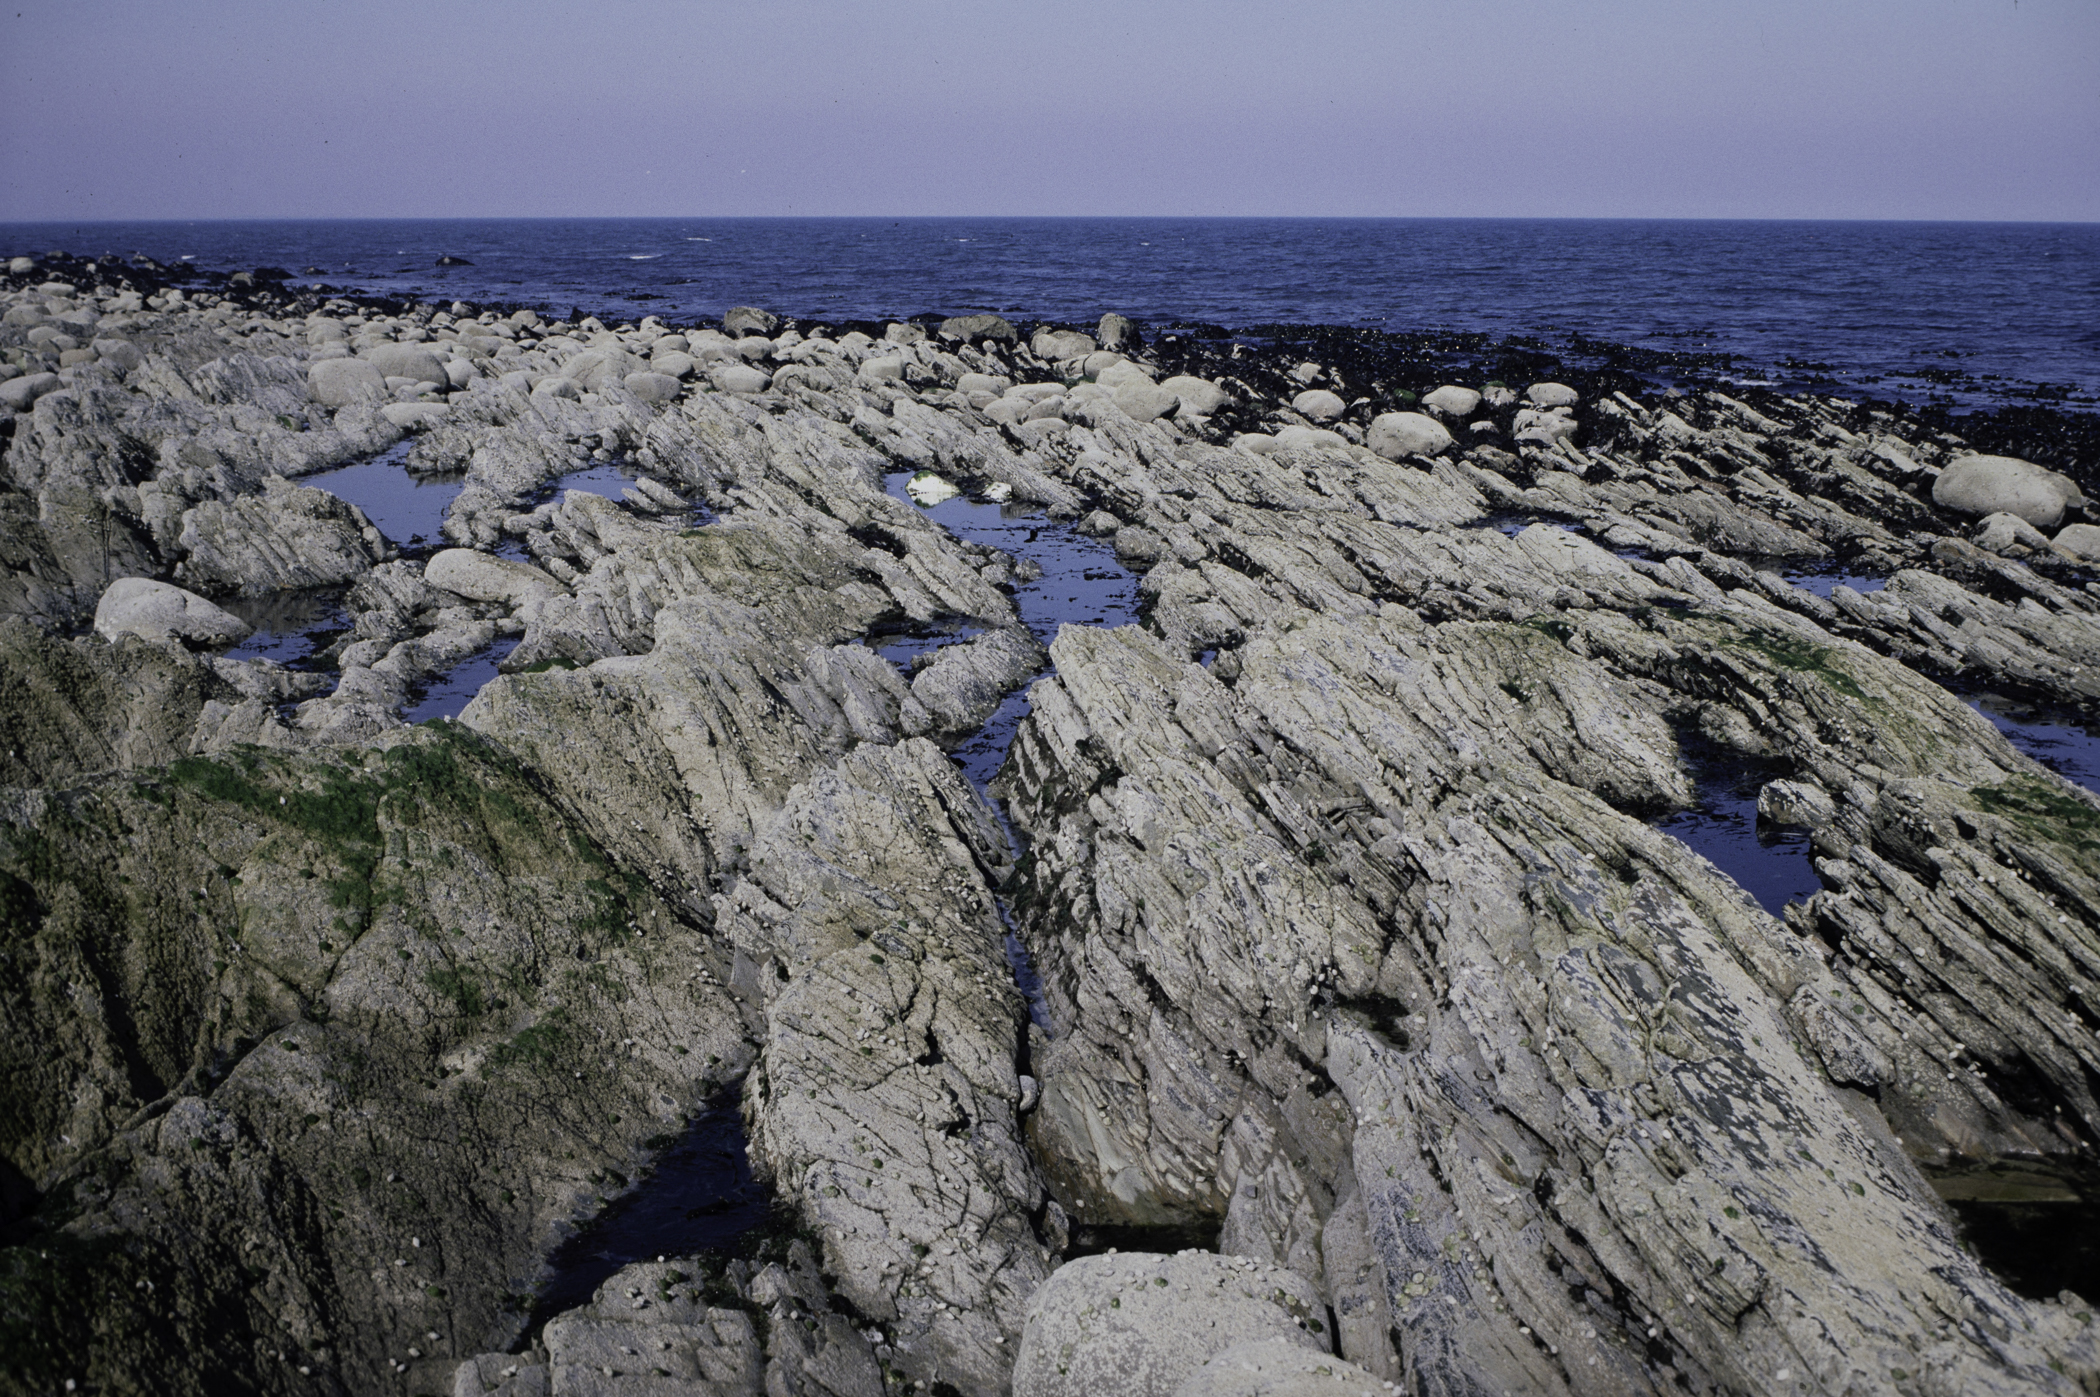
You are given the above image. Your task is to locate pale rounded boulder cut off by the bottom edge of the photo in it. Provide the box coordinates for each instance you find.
[1014,1252,1327,1397]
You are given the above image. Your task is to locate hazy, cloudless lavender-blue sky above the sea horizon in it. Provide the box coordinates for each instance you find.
[0,0,2100,221]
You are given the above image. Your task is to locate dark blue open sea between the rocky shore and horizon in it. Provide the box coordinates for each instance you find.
[0,218,2100,405]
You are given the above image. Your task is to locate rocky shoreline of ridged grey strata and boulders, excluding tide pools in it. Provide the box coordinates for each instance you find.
[0,256,2100,1397]
